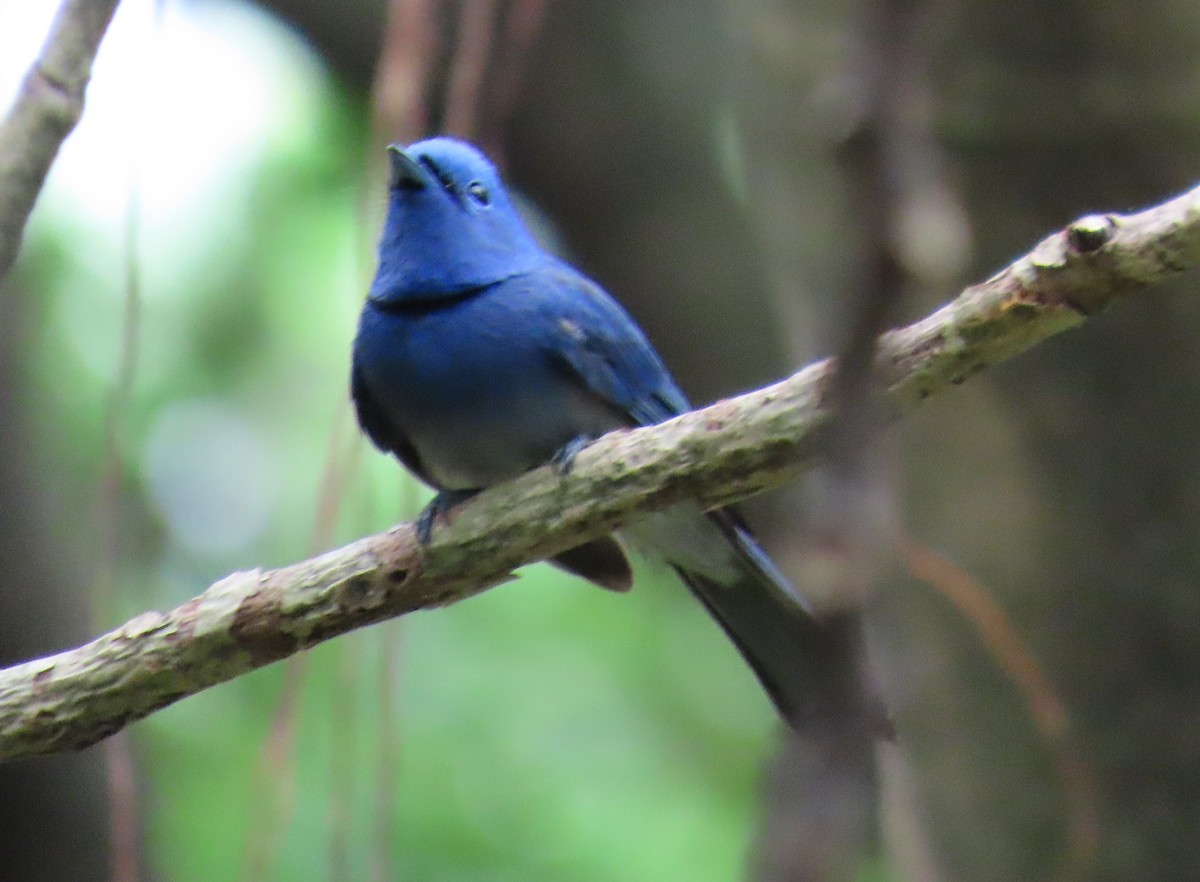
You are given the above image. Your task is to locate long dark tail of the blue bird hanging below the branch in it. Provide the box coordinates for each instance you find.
[629,505,893,738]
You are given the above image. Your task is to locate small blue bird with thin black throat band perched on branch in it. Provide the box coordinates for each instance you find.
[350,138,868,727]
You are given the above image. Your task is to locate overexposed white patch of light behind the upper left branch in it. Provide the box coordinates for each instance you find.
[0,0,325,292]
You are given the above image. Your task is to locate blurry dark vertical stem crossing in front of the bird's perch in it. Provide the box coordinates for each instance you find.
[756,0,969,882]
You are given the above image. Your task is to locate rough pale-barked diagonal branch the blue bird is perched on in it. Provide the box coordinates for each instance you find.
[0,187,1200,760]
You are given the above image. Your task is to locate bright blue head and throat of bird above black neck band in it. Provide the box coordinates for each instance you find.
[371,138,548,304]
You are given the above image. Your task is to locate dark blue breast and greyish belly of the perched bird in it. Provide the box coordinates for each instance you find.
[356,294,619,490]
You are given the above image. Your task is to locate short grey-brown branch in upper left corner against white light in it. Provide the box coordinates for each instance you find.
[0,0,118,280]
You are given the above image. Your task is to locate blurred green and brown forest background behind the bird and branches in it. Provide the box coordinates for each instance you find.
[0,0,1200,882]
